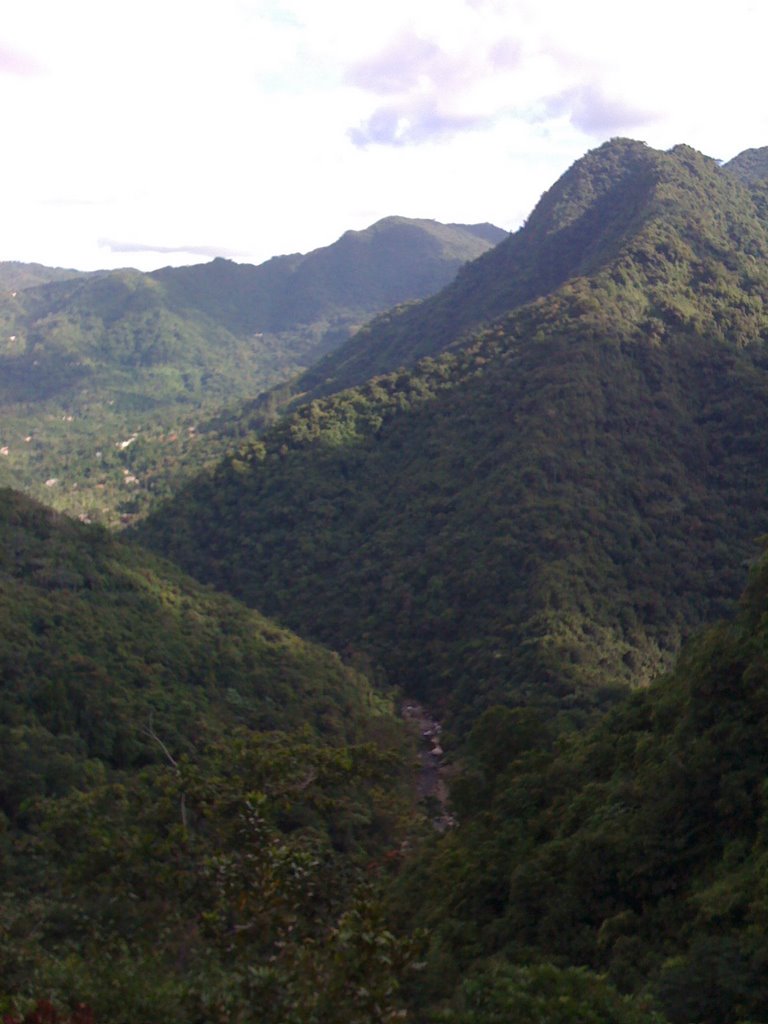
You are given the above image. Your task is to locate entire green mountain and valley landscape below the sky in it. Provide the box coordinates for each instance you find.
[0,139,768,1024]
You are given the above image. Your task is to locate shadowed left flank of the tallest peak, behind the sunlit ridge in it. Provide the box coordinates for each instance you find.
[296,139,676,395]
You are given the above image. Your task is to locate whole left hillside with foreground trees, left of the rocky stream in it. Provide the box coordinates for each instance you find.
[0,492,416,1024]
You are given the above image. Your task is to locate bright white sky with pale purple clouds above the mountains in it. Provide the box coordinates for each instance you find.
[0,0,768,270]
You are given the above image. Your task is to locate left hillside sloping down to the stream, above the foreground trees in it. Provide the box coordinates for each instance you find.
[0,490,391,819]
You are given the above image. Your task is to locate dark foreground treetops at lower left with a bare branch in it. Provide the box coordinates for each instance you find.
[0,730,419,1024]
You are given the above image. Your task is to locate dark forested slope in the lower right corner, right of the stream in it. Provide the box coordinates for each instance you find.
[397,558,768,1024]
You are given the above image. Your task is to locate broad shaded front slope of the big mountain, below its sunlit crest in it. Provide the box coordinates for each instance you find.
[140,323,766,721]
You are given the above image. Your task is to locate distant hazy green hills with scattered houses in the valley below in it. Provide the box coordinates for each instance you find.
[0,217,504,524]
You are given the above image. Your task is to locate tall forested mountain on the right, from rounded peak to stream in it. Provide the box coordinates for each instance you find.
[141,141,768,723]
